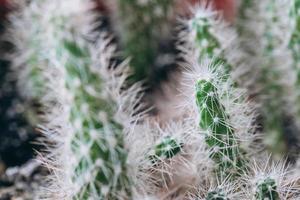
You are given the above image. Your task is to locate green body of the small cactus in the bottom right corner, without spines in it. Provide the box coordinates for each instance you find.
[255,177,280,200]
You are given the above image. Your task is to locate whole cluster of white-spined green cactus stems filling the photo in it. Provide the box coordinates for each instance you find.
[7,0,300,200]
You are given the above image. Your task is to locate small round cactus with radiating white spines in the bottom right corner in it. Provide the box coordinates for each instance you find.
[243,157,299,200]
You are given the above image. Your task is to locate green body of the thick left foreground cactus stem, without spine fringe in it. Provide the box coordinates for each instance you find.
[62,40,130,199]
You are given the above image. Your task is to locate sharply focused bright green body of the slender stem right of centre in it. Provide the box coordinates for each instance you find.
[196,80,243,178]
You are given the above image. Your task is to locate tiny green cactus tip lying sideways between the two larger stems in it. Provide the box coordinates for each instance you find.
[150,136,183,162]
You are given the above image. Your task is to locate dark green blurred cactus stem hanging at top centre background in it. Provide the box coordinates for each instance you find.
[115,0,174,81]
